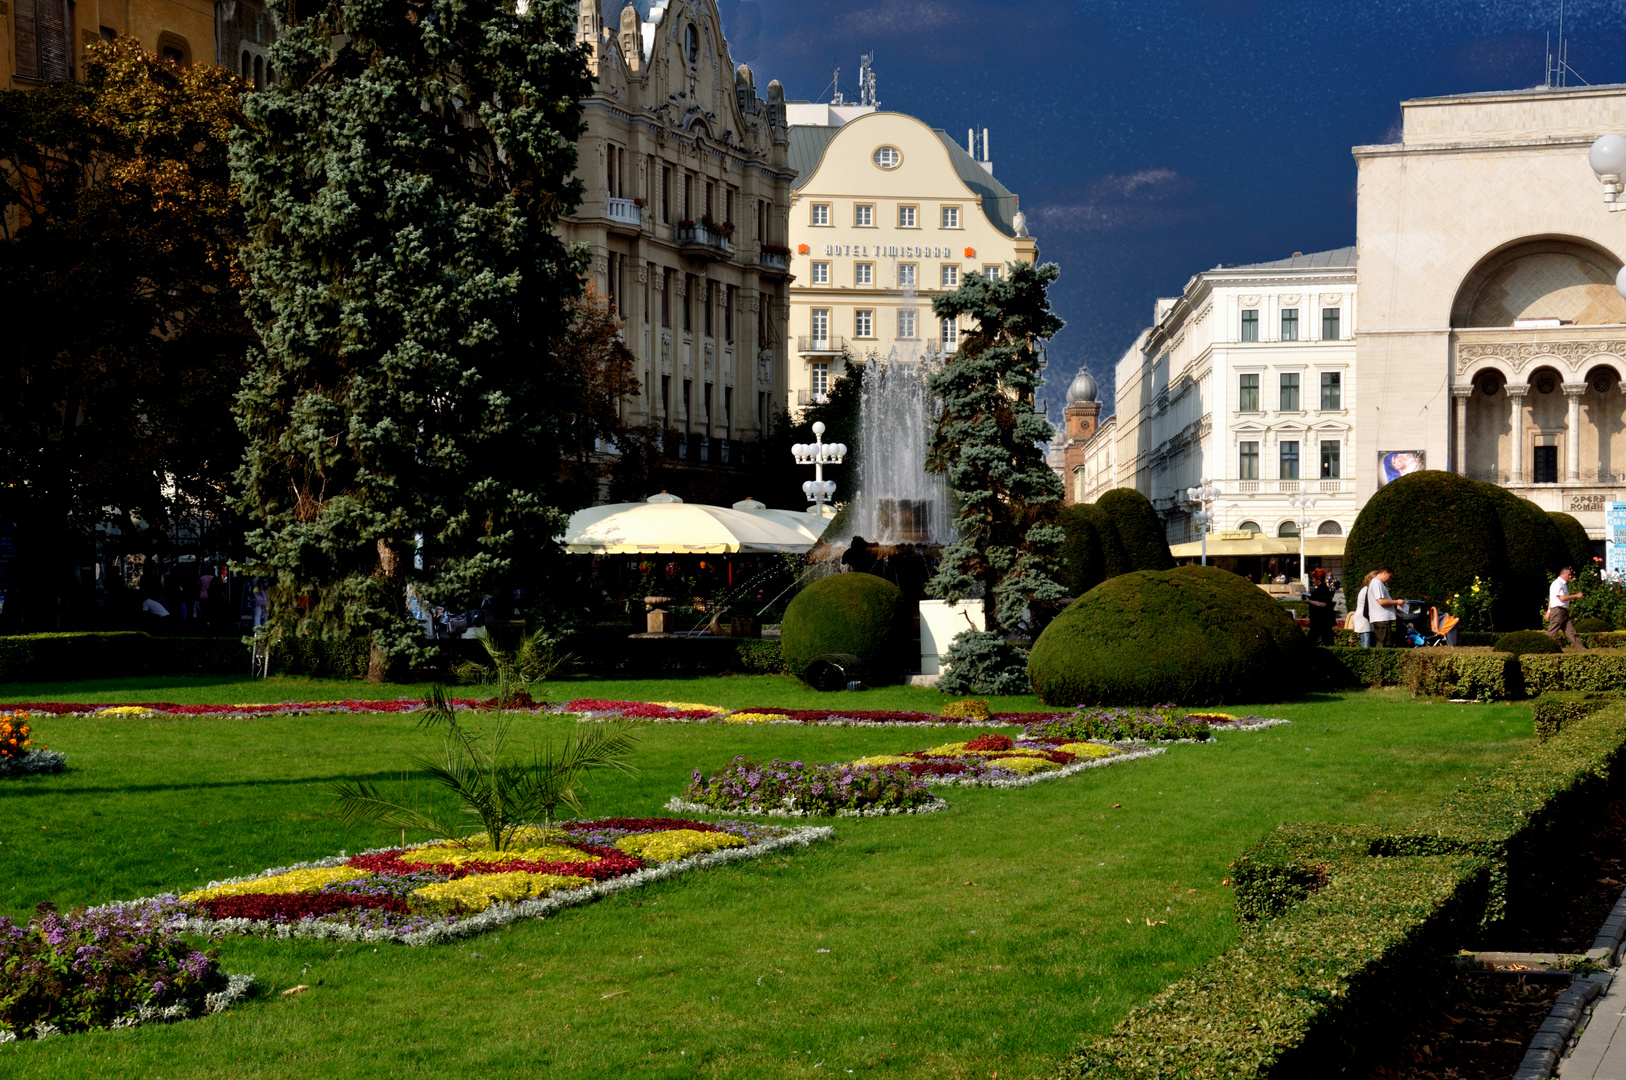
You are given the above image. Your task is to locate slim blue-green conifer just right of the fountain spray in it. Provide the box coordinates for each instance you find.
[927,262,1067,634]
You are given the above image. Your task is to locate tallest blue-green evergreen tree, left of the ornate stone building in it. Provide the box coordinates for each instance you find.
[231,0,590,680]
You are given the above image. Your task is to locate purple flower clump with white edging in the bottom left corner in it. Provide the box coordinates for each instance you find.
[0,904,254,1043]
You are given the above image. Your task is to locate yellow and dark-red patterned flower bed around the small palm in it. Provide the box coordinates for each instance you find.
[102,818,831,945]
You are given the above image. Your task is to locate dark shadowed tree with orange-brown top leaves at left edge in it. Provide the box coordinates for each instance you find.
[0,42,252,629]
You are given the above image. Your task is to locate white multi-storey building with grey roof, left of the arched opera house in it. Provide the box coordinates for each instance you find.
[1063,247,1361,553]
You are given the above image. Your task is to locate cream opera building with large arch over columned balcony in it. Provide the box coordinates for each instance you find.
[1354,86,1626,538]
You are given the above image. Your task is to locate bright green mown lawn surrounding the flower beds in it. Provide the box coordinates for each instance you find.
[0,678,1530,1080]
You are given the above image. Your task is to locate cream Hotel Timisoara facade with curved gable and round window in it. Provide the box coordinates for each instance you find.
[789,110,1039,408]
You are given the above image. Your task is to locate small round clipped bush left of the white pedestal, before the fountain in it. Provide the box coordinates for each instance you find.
[779,571,912,683]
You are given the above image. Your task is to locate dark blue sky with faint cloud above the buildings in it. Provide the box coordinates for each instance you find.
[719,0,1626,416]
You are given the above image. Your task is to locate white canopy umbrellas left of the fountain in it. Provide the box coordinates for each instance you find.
[564,493,826,555]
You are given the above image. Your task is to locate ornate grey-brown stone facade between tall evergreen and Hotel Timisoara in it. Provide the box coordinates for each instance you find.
[559,0,793,467]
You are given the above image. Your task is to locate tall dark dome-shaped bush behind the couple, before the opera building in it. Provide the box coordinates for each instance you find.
[1343,470,1507,602]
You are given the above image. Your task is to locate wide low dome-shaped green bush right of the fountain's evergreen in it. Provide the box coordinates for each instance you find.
[1028,566,1309,706]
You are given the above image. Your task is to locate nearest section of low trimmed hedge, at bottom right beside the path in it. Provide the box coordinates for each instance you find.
[1062,856,1486,1080]
